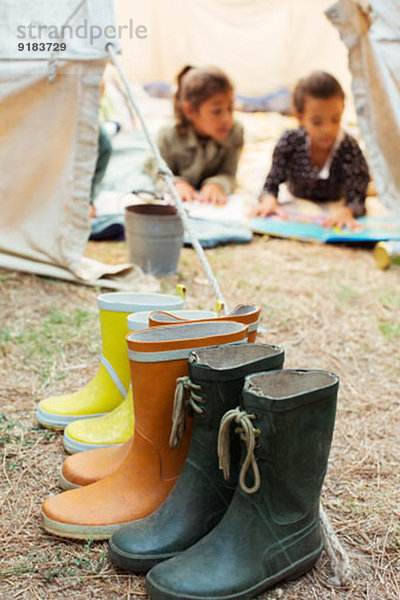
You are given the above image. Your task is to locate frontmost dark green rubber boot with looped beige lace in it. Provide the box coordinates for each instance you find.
[147,370,339,600]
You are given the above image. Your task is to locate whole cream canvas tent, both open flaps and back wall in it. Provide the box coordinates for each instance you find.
[0,0,400,281]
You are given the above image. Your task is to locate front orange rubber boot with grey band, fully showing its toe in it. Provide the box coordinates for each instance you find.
[42,321,247,539]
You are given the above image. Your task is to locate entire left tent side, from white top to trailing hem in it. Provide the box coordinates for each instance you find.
[0,0,147,288]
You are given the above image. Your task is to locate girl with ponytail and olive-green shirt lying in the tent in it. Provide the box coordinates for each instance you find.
[146,66,243,204]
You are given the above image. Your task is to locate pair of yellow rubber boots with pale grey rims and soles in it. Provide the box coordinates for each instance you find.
[37,292,184,453]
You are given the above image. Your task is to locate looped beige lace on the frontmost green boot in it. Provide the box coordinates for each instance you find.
[218,407,261,494]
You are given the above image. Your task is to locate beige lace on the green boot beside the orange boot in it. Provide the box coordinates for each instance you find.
[169,376,205,448]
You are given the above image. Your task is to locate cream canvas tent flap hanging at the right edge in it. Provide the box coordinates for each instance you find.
[327,0,400,217]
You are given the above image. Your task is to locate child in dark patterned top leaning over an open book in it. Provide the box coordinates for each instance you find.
[254,71,369,229]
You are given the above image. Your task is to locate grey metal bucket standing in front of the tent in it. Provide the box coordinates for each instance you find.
[125,204,183,275]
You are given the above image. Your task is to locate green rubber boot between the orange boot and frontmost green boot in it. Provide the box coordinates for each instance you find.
[109,344,284,572]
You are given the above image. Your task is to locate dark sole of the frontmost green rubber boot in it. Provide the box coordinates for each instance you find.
[146,544,323,600]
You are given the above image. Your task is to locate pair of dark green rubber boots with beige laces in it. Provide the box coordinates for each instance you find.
[109,344,339,600]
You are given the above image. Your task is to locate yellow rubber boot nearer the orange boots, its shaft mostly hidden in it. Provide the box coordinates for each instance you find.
[64,309,216,454]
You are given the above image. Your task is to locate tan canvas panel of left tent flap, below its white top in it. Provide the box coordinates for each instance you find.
[0,60,104,272]
